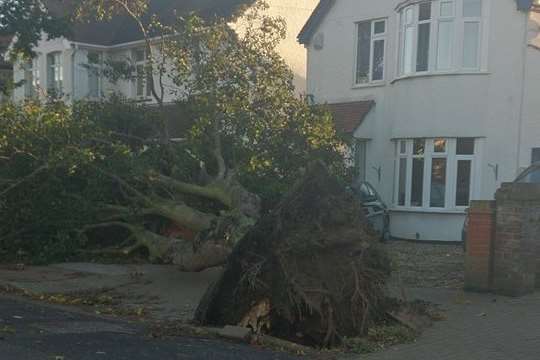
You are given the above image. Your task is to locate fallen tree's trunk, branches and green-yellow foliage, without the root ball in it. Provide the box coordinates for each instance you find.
[0,2,345,271]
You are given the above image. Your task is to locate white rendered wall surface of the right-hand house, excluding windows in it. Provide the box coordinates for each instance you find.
[308,0,540,240]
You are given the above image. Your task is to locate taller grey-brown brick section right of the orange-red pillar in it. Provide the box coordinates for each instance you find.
[493,183,540,296]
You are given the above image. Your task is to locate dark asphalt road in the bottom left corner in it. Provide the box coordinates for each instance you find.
[0,295,297,360]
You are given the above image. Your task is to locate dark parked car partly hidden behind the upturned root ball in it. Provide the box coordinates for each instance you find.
[351,181,390,241]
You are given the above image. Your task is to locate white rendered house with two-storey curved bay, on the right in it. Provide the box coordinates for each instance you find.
[298,0,540,241]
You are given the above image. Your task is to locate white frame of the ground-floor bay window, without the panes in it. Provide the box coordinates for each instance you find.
[394,137,479,212]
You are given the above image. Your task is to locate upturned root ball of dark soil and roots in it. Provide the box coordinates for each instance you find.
[196,163,390,347]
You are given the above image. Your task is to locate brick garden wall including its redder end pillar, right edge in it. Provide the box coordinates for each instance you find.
[465,183,540,296]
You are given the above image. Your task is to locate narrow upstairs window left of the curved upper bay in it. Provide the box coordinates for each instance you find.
[355,19,387,85]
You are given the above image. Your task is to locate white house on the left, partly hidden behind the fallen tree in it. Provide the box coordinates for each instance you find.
[14,0,318,103]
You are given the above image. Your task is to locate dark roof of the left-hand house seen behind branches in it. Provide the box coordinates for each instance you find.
[46,0,254,46]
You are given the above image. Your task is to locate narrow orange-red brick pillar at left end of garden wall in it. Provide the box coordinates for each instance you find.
[465,201,495,291]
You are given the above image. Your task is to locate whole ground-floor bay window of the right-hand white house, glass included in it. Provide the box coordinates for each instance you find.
[395,138,476,210]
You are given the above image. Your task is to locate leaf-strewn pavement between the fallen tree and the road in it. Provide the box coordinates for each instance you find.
[0,263,221,322]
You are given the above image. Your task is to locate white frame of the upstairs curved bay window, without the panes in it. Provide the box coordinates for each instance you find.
[396,0,489,79]
